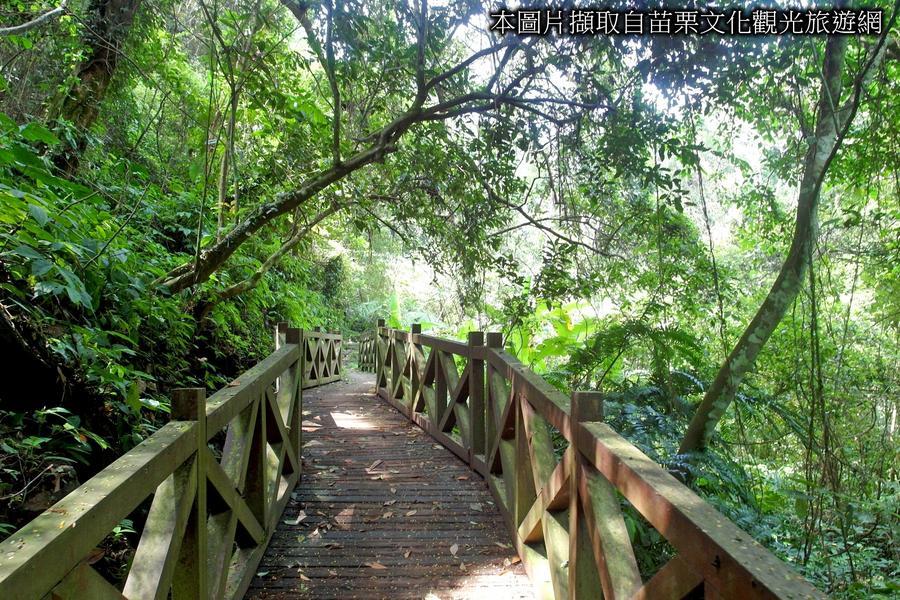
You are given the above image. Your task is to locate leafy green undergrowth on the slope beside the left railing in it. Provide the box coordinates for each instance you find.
[0,115,358,537]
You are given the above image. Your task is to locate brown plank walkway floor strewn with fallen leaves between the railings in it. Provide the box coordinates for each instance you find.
[247,372,533,600]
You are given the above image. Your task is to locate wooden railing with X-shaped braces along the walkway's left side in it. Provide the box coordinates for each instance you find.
[0,323,340,600]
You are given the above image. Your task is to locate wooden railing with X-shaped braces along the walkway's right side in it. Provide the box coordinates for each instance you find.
[376,321,824,600]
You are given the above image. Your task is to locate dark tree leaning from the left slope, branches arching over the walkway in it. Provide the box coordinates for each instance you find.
[156,0,611,293]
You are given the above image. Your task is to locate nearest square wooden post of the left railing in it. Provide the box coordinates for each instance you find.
[171,388,209,600]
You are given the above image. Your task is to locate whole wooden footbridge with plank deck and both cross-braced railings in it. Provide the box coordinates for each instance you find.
[0,322,824,600]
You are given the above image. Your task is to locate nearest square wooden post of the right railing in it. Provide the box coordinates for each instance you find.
[569,392,605,600]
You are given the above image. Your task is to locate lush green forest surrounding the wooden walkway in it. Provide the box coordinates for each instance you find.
[0,0,900,598]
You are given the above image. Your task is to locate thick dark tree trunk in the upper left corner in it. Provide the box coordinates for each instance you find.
[53,0,141,173]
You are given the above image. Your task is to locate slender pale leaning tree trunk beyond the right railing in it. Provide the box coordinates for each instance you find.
[678,36,855,454]
